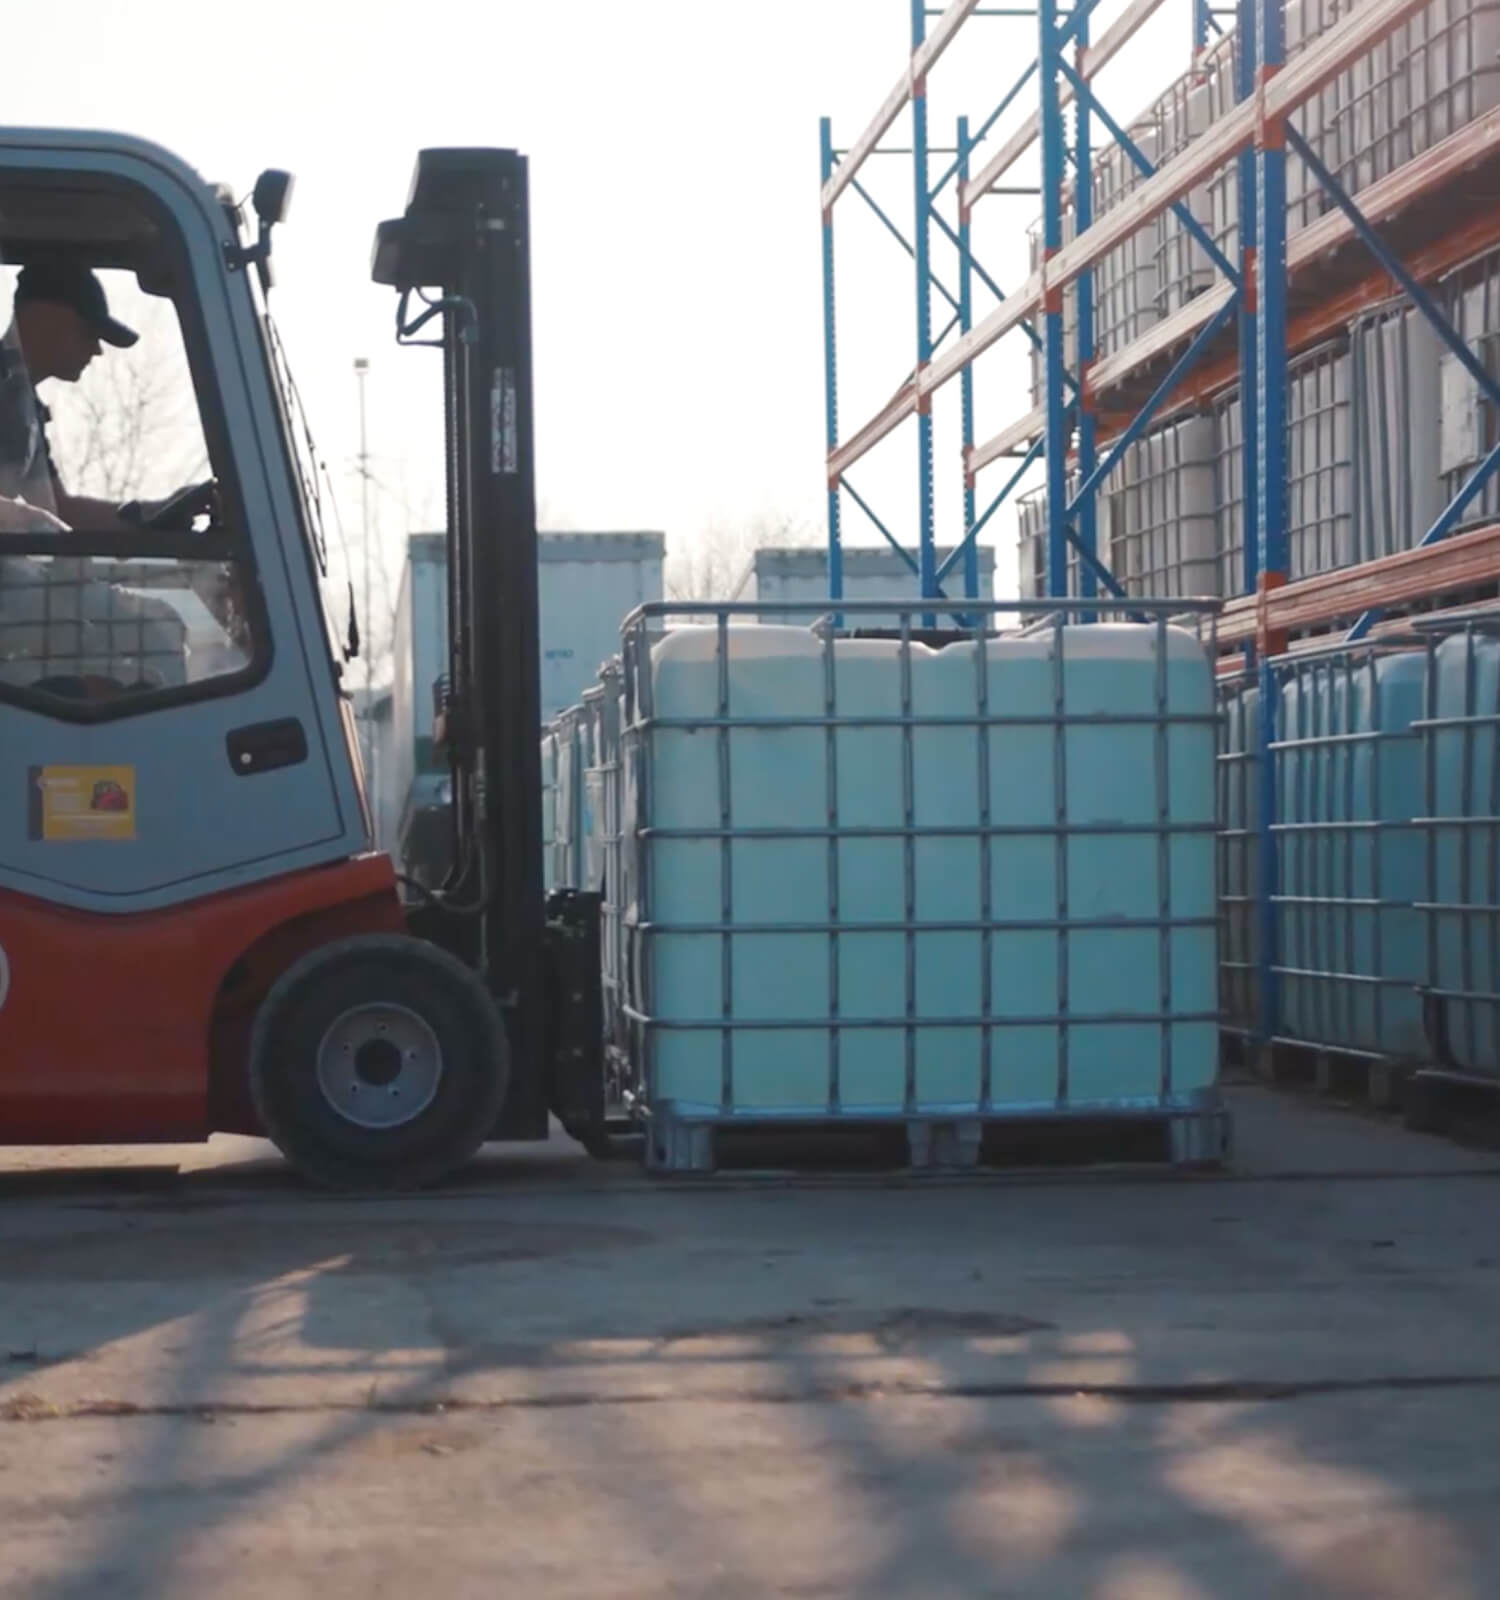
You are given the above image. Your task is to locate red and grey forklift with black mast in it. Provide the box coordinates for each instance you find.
[0,130,609,1192]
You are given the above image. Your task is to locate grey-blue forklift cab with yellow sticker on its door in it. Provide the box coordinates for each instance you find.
[0,134,371,915]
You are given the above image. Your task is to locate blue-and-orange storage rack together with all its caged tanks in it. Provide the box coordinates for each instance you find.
[799,0,1500,1120]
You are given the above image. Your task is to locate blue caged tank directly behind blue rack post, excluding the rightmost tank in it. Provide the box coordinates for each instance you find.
[1220,643,1426,1059]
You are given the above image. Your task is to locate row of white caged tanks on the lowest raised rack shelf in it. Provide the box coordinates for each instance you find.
[1019,268,1464,597]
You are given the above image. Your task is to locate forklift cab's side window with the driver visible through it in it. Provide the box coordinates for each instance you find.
[0,186,267,717]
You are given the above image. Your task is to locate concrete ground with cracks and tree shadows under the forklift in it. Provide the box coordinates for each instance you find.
[0,1090,1500,1600]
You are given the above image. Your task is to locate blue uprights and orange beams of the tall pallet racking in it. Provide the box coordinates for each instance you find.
[820,0,1500,1035]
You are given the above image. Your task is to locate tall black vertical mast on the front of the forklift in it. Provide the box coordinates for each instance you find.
[371,149,555,1138]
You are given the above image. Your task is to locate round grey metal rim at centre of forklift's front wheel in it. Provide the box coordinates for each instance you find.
[318,1002,443,1128]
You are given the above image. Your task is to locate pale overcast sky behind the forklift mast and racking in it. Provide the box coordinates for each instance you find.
[6,0,1188,601]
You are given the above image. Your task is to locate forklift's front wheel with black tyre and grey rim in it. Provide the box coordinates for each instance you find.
[249,934,510,1192]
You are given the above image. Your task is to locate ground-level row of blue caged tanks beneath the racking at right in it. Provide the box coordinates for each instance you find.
[1219,613,1500,1078]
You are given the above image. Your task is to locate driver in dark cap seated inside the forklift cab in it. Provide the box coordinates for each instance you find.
[0,262,139,533]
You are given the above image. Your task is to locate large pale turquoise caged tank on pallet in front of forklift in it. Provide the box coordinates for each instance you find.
[550,601,1222,1165]
